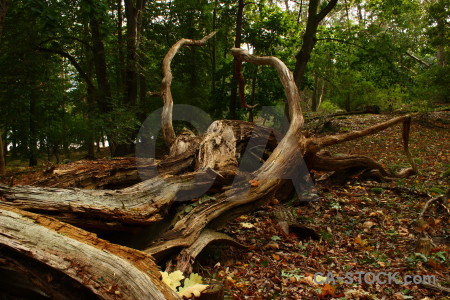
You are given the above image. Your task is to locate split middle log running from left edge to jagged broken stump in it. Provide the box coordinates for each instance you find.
[0,121,279,231]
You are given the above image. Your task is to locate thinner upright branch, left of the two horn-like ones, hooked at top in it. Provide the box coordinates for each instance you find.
[161,32,216,147]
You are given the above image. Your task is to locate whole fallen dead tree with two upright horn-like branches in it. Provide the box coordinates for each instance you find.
[0,35,416,299]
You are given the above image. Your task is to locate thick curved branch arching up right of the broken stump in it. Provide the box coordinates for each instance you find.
[146,48,306,254]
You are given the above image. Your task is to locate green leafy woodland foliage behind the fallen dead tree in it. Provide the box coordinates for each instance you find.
[0,0,450,163]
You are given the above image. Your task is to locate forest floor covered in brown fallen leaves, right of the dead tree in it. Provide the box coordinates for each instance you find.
[0,112,450,299]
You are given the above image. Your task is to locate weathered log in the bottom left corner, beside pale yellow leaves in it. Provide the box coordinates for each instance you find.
[0,206,178,299]
